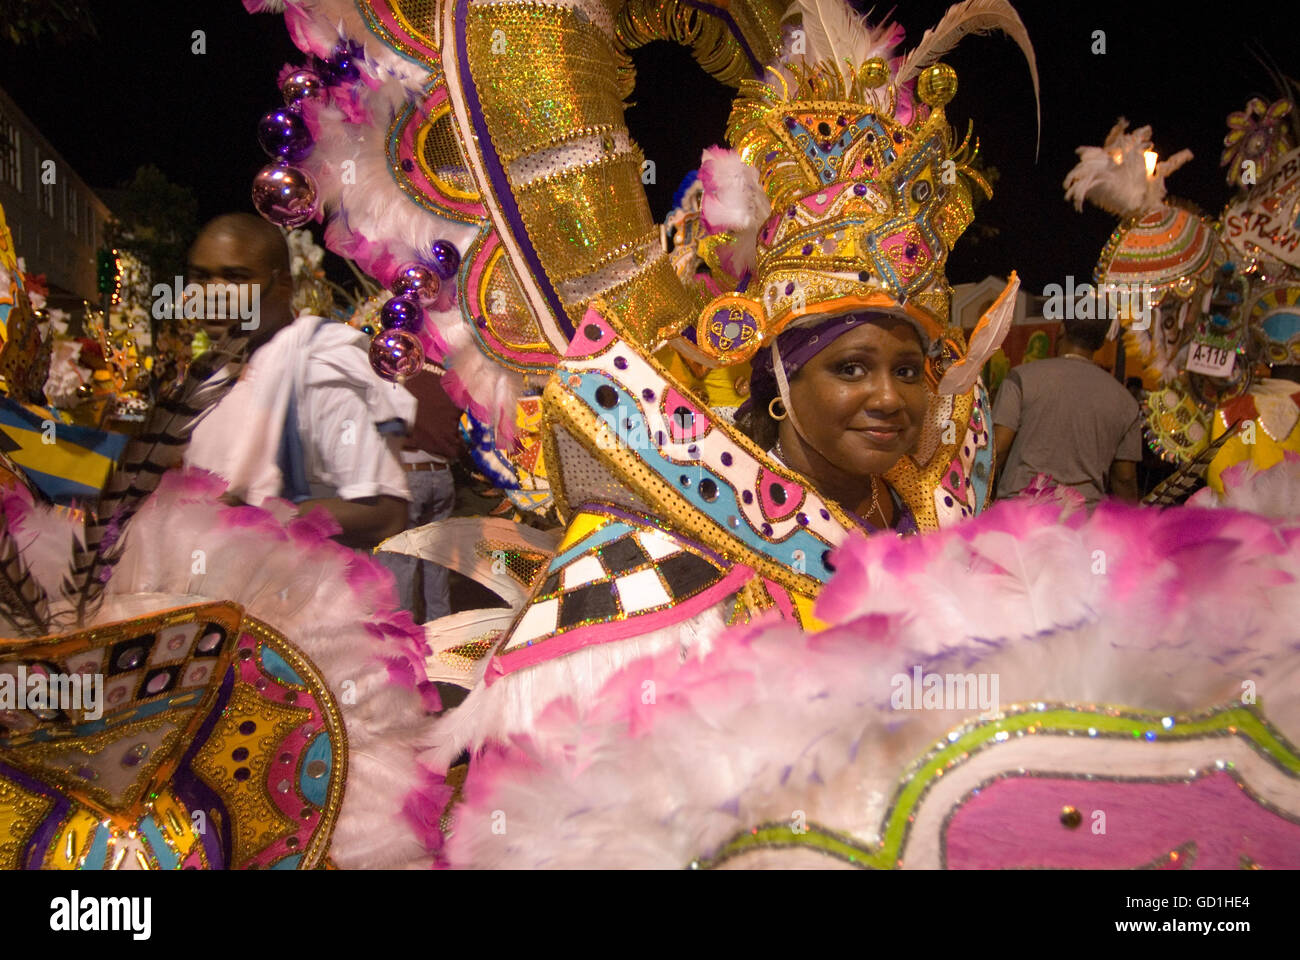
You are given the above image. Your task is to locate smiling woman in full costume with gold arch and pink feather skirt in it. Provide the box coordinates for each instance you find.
[226,0,1300,866]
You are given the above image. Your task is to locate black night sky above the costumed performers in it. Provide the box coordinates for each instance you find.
[0,0,1300,291]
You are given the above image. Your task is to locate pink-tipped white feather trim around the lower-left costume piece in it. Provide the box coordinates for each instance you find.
[0,471,450,868]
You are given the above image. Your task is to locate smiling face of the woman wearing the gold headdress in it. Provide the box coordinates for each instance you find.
[783,315,930,477]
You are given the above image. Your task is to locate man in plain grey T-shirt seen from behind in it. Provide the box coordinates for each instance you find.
[993,320,1141,510]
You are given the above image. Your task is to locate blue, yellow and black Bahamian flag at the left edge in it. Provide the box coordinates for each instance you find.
[0,397,126,505]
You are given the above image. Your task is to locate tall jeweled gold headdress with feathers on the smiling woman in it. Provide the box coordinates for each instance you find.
[696,0,1037,390]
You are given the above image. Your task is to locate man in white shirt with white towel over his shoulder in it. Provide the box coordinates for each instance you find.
[185,213,416,549]
